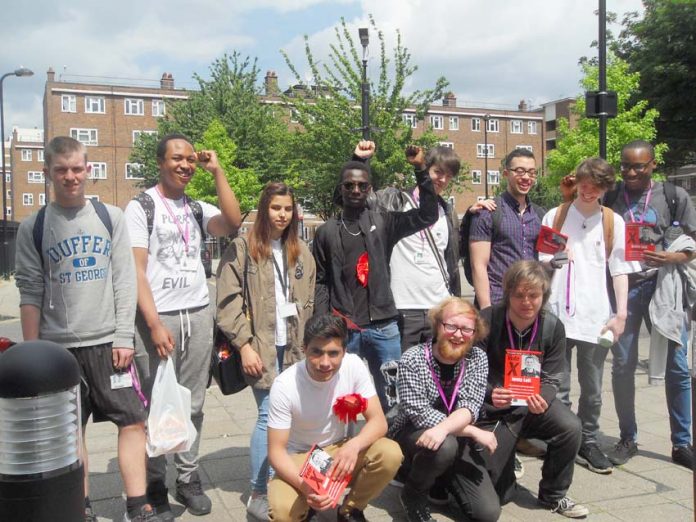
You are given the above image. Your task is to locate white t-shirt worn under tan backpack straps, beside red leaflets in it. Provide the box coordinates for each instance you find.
[539,205,640,343]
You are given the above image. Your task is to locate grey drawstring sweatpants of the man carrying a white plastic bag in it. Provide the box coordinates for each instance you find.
[135,305,213,484]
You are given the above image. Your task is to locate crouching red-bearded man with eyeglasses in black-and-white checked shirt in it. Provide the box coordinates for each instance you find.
[389,297,500,522]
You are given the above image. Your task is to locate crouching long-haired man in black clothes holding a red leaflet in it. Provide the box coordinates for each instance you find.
[478,261,589,518]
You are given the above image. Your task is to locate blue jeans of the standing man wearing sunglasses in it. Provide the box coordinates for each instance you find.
[346,320,401,411]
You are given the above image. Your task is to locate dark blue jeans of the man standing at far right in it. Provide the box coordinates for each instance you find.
[611,277,691,446]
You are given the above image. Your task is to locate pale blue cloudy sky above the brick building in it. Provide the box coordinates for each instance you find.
[0,0,641,135]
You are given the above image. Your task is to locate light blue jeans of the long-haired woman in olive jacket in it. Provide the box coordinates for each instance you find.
[249,346,285,495]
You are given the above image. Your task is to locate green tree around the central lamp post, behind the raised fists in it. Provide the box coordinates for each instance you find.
[283,18,447,218]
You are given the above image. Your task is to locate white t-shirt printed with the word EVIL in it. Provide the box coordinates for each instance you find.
[126,187,220,313]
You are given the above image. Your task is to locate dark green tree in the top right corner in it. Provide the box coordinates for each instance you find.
[616,0,696,167]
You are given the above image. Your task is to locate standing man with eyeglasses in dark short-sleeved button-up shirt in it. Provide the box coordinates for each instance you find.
[469,149,546,309]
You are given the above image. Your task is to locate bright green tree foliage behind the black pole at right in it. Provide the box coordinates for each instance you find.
[541,54,666,187]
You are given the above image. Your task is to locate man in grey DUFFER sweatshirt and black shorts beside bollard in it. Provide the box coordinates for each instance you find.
[15,136,160,522]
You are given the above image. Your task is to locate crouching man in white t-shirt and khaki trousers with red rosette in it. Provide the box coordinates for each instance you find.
[268,314,403,522]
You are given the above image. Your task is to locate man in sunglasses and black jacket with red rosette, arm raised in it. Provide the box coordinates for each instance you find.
[313,141,438,411]
